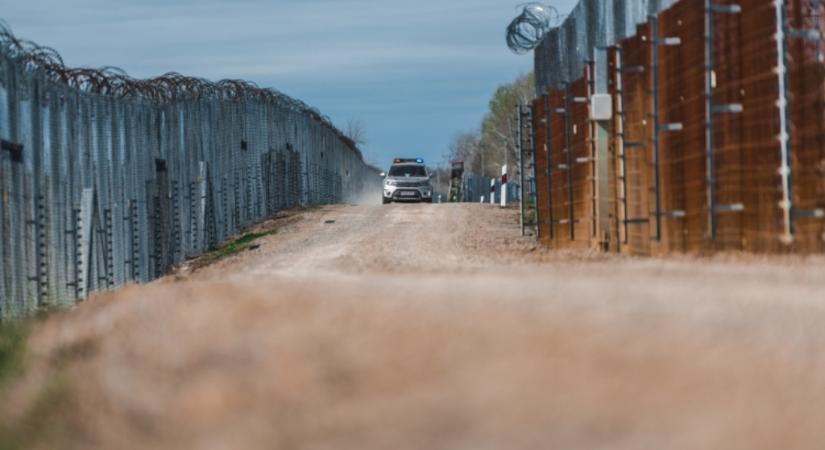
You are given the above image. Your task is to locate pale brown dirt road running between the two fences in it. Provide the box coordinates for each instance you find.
[0,205,825,450]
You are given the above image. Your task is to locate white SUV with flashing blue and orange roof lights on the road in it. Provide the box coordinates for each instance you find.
[383,158,433,204]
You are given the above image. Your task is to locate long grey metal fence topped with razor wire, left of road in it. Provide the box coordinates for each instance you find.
[0,24,380,320]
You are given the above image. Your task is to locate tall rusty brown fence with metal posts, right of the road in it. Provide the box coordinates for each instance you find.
[532,0,825,255]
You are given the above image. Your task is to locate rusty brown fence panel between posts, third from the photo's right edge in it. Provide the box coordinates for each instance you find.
[649,0,708,252]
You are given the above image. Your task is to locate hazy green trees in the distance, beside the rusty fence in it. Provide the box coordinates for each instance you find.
[449,72,535,176]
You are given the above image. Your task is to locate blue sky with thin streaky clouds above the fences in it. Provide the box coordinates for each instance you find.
[0,0,575,167]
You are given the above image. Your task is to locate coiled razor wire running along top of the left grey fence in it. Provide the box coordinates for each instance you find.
[0,19,358,151]
